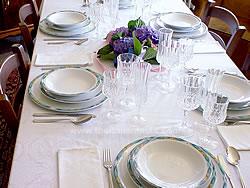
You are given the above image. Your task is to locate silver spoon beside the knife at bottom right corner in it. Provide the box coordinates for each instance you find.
[227,146,246,188]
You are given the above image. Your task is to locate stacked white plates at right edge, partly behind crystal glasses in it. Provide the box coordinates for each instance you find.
[219,73,250,121]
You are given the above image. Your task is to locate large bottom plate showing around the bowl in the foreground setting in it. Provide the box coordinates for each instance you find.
[112,137,228,188]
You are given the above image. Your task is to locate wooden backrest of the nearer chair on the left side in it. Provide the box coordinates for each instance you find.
[0,44,30,129]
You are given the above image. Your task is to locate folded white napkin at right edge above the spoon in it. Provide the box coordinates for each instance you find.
[218,125,250,151]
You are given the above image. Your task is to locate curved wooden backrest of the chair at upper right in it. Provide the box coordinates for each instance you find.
[205,6,246,57]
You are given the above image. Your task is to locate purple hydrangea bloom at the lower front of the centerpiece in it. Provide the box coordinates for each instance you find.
[113,37,134,54]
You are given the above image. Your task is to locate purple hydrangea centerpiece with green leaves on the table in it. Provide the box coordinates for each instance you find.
[97,18,159,66]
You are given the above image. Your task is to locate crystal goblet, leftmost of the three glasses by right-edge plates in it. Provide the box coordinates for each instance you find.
[178,73,203,135]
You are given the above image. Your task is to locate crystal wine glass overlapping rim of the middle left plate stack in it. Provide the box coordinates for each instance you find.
[102,69,121,121]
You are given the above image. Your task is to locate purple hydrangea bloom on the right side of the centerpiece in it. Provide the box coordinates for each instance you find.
[135,26,159,44]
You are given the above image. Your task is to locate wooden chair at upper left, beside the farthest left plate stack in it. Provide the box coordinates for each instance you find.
[19,0,39,57]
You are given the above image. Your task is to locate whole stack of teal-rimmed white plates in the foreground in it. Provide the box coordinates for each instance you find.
[113,137,227,188]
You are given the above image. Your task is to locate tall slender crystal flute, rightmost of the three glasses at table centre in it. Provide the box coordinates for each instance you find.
[133,61,151,123]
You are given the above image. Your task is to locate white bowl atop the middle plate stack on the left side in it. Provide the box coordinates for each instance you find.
[41,67,97,97]
